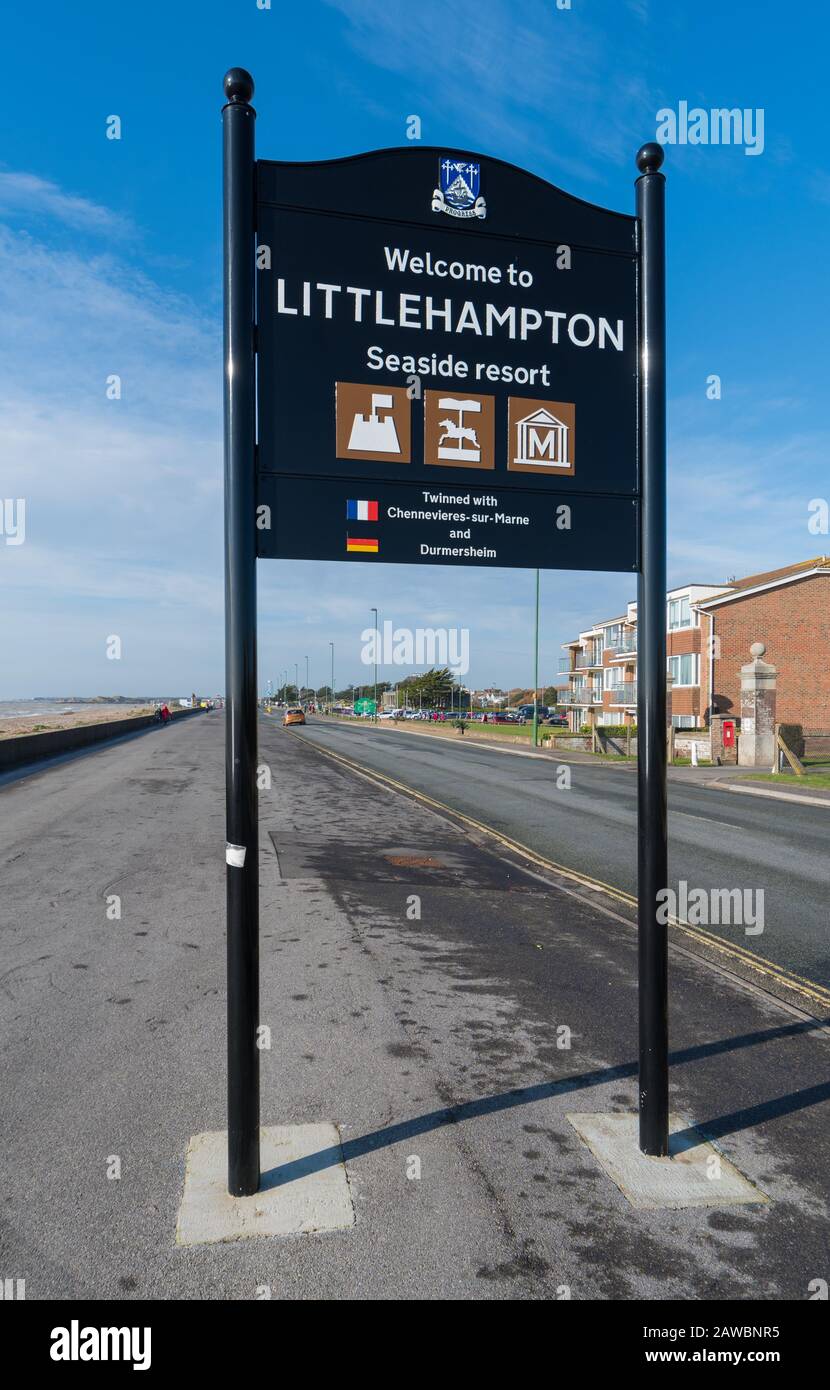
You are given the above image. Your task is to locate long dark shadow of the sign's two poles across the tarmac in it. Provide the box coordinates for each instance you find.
[260,1017,830,1191]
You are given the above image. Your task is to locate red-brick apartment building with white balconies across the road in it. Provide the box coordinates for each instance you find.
[560,556,830,733]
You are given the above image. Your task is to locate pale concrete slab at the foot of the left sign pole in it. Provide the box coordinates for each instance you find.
[175,1123,355,1245]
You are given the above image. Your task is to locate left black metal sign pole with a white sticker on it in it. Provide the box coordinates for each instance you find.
[222,68,260,1197]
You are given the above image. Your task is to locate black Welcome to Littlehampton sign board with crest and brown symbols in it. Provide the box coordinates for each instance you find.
[257,147,638,570]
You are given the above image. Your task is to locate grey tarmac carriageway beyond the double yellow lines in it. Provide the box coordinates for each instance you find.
[293,719,830,987]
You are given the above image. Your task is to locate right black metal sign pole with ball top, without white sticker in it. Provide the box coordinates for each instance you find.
[637,143,669,1156]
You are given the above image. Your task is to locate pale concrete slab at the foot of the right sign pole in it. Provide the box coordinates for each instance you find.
[567,1113,769,1209]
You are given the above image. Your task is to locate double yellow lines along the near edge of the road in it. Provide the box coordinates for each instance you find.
[293,738,830,1008]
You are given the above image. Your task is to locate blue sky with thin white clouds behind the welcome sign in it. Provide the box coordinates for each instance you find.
[0,0,830,699]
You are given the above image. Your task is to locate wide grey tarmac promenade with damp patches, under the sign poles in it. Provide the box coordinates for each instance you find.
[0,713,830,1295]
